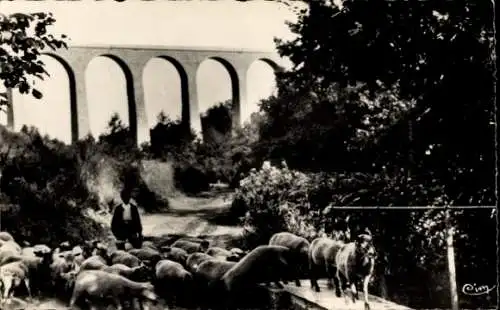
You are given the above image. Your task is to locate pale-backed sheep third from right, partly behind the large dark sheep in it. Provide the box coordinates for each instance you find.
[269,232,310,286]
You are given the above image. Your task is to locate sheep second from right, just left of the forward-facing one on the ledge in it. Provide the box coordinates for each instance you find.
[309,237,344,297]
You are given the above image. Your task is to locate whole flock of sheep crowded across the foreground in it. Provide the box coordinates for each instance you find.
[0,232,375,309]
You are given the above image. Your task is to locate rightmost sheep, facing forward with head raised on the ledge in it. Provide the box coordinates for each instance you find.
[335,234,375,310]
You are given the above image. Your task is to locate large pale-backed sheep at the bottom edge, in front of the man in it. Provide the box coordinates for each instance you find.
[70,270,158,309]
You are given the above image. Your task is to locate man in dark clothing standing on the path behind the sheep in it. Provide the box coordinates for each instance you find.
[111,189,142,248]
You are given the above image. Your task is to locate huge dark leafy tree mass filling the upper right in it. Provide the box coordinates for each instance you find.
[272,0,495,205]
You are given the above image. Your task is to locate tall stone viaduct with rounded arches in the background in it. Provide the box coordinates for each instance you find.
[2,45,283,142]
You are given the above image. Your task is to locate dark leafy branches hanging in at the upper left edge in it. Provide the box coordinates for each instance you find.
[0,13,67,107]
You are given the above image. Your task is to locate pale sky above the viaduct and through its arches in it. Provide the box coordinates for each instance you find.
[0,0,295,142]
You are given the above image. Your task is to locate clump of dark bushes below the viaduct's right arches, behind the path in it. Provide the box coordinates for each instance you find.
[144,101,258,194]
